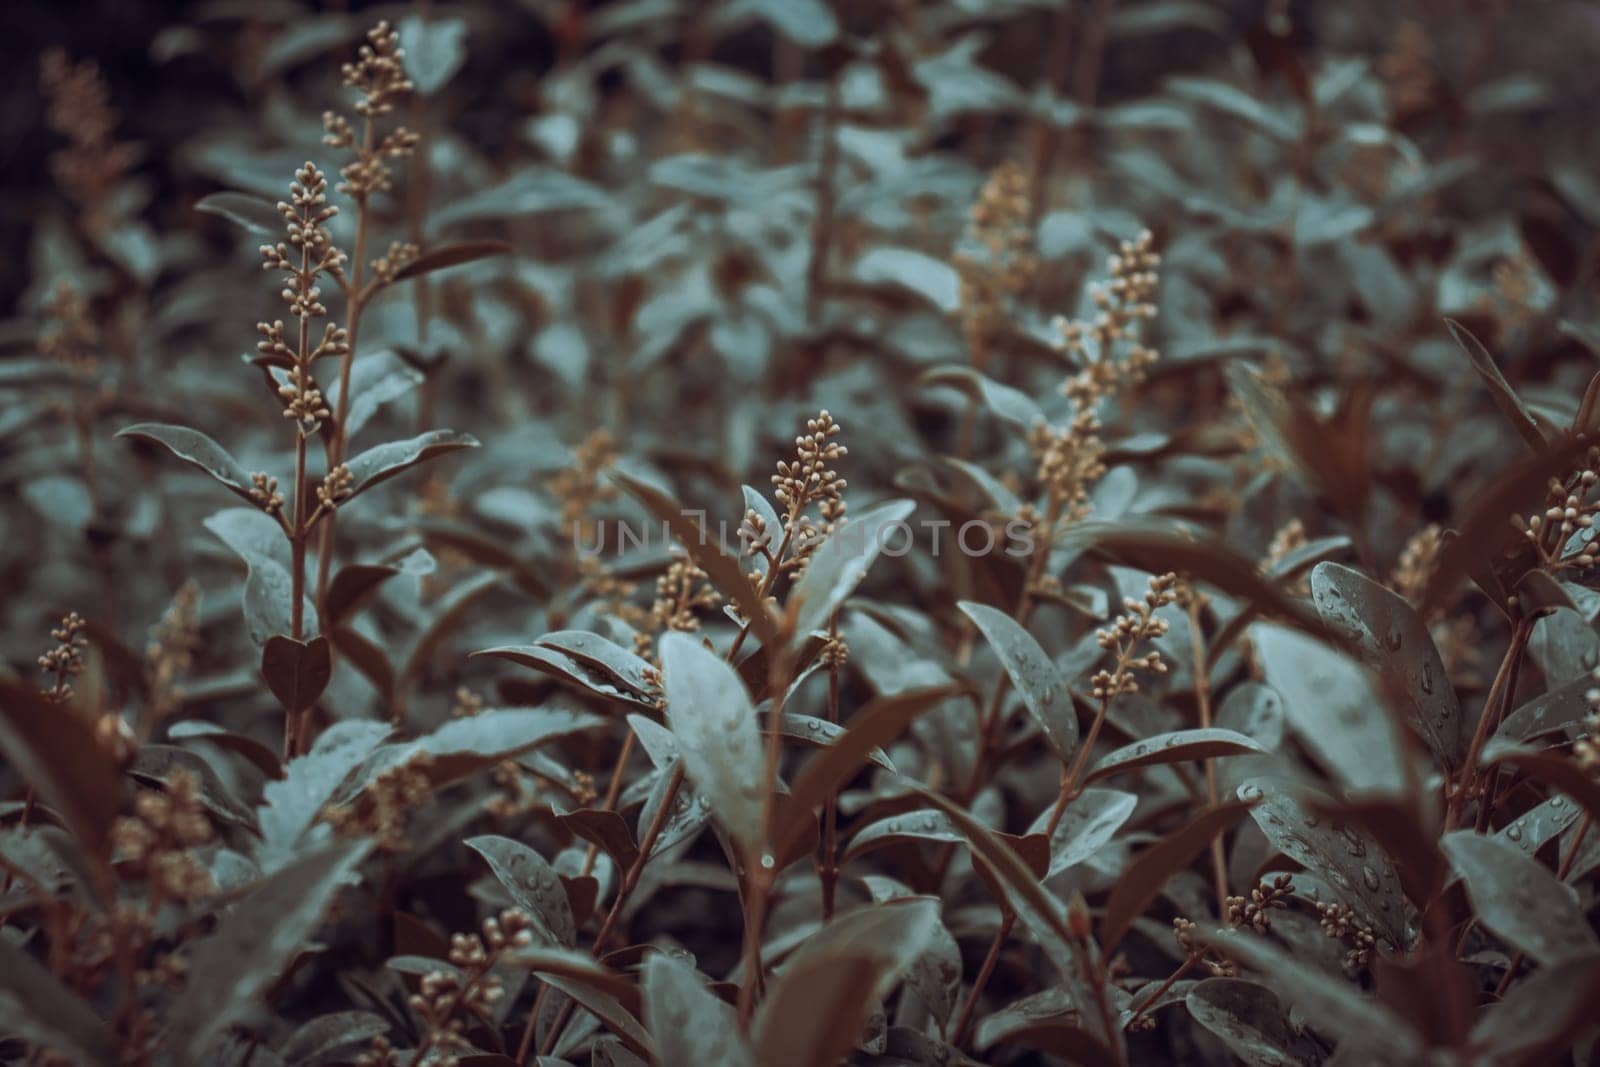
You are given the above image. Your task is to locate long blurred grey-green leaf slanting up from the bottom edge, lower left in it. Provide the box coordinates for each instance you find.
[163,841,370,1064]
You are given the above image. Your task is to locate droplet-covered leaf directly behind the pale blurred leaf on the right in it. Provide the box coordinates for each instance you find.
[1310,563,1466,769]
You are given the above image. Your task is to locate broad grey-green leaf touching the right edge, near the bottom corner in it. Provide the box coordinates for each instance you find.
[1440,830,1600,963]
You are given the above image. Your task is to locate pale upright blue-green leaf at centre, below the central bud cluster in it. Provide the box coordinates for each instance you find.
[661,632,765,857]
